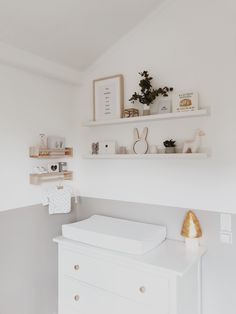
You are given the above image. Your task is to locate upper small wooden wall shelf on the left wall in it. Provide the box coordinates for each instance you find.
[29,146,73,159]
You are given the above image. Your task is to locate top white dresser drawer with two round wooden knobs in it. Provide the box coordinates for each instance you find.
[59,249,169,313]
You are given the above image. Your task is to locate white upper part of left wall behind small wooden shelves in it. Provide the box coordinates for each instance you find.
[0,65,76,211]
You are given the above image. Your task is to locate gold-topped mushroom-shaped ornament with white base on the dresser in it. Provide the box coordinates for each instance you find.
[181,210,202,250]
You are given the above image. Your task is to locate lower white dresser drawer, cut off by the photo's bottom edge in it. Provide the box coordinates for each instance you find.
[59,276,159,314]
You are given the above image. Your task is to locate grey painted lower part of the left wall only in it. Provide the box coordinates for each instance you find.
[0,201,77,314]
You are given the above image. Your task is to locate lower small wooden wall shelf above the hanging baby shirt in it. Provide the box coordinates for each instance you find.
[30,171,73,185]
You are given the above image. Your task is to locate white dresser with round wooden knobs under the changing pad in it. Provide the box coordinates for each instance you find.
[54,237,205,314]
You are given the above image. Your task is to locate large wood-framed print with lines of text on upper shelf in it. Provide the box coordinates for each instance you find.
[93,74,124,121]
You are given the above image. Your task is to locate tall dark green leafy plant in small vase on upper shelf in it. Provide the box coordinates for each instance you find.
[129,71,173,115]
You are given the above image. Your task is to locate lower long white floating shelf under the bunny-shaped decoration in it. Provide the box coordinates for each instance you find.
[82,153,208,159]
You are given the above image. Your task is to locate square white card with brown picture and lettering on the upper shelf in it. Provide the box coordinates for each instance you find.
[172,91,198,112]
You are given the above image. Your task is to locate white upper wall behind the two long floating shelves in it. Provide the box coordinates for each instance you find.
[77,0,236,212]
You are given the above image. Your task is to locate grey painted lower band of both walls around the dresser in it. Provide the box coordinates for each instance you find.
[0,198,236,314]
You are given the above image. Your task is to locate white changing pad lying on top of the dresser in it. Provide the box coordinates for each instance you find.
[62,215,166,255]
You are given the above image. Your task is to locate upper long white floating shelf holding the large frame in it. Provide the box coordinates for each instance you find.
[84,109,207,127]
